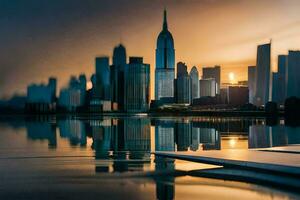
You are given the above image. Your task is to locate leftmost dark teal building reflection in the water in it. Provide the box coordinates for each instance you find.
[26,122,57,148]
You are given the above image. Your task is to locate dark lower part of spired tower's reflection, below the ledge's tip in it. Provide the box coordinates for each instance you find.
[155,156,175,200]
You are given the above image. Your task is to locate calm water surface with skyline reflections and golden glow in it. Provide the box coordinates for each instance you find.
[0,116,300,199]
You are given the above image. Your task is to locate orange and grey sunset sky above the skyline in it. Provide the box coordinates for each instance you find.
[0,0,300,97]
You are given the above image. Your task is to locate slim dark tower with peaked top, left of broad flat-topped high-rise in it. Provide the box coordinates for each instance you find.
[110,44,127,110]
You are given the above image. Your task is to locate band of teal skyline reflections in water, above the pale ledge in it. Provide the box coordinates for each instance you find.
[14,118,300,152]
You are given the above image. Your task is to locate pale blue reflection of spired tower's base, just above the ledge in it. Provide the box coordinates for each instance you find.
[155,120,175,151]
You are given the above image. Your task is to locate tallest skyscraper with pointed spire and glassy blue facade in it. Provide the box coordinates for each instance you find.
[155,10,175,100]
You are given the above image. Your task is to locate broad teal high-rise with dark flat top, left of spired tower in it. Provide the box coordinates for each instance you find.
[124,57,150,112]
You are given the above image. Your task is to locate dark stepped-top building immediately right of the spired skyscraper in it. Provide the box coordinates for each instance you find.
[174,62,191,104]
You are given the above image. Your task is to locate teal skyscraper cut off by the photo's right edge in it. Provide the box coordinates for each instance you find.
[287,51,300,98]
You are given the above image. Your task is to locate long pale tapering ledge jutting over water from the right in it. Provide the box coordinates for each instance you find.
[153,150,300,177]
